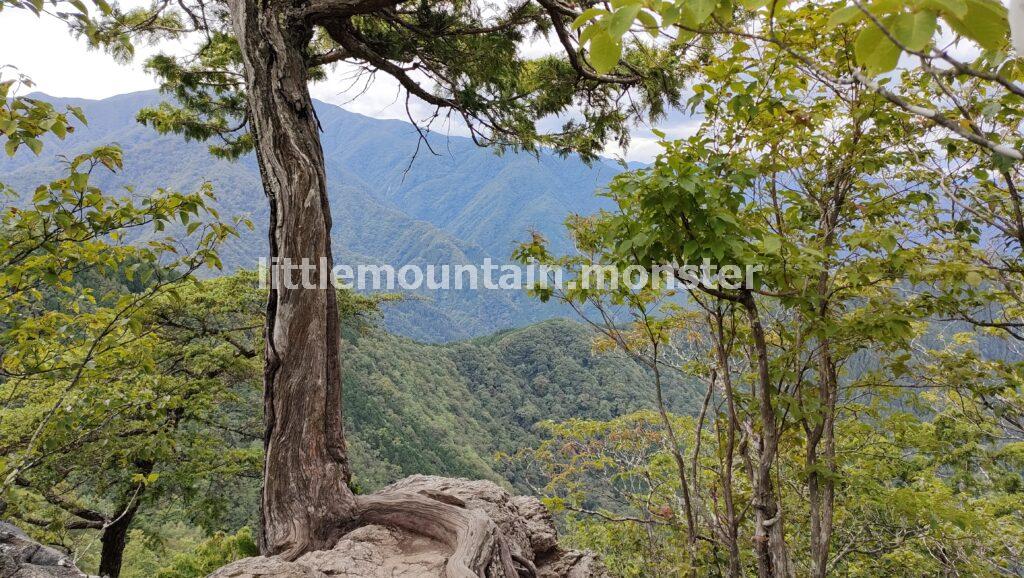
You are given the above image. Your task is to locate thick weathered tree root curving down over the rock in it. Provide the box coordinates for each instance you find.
[355,492,531,578]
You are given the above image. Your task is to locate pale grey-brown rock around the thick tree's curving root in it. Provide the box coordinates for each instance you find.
[209,476,607,578]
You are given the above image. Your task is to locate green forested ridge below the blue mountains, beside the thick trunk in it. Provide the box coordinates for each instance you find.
[342,320,699,488]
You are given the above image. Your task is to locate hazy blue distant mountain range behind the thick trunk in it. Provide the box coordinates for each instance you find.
[0,91,620,341]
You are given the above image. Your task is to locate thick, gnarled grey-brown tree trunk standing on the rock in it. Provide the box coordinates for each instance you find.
[230,0,356,560]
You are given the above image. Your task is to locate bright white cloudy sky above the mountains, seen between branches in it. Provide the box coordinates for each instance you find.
[0,7,697,162]
